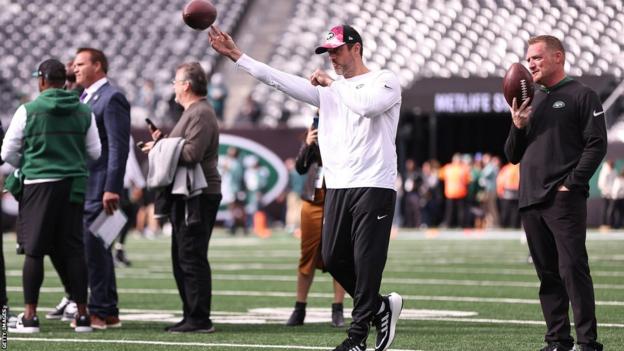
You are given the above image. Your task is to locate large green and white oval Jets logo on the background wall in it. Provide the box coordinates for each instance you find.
[218,134,288,219]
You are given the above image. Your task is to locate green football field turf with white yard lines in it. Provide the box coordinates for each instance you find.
[4,229,624,351]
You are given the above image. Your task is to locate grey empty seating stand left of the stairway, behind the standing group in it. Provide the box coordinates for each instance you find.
[0,0,248,125]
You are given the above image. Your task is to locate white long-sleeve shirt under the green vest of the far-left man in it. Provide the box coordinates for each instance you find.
[0,105,102,184]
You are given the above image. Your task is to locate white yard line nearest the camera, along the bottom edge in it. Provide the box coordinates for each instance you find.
[8,337,422,351]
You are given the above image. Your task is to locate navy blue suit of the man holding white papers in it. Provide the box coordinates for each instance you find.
[84,83,130,318]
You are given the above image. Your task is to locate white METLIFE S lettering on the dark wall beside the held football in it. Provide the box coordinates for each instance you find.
[433,92,509,113]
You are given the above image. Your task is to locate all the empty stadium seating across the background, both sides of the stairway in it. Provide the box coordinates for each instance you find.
[0,0,624,126]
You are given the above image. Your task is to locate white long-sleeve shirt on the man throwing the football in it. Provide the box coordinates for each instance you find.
[236,55,401,189]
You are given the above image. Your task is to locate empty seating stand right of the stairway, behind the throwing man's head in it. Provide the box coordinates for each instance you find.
[254,0,624,125]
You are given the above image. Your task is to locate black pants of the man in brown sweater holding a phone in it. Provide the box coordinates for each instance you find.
[171,194,221,327]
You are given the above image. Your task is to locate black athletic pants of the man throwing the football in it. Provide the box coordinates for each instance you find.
[321,188,396,340]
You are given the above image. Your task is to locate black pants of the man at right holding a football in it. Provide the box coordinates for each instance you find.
[520,191,597,345]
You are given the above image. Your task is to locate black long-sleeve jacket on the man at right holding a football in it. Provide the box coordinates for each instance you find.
[505,77,607,208]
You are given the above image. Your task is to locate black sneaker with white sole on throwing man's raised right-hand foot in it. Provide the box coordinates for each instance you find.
[373,292,403,351]
